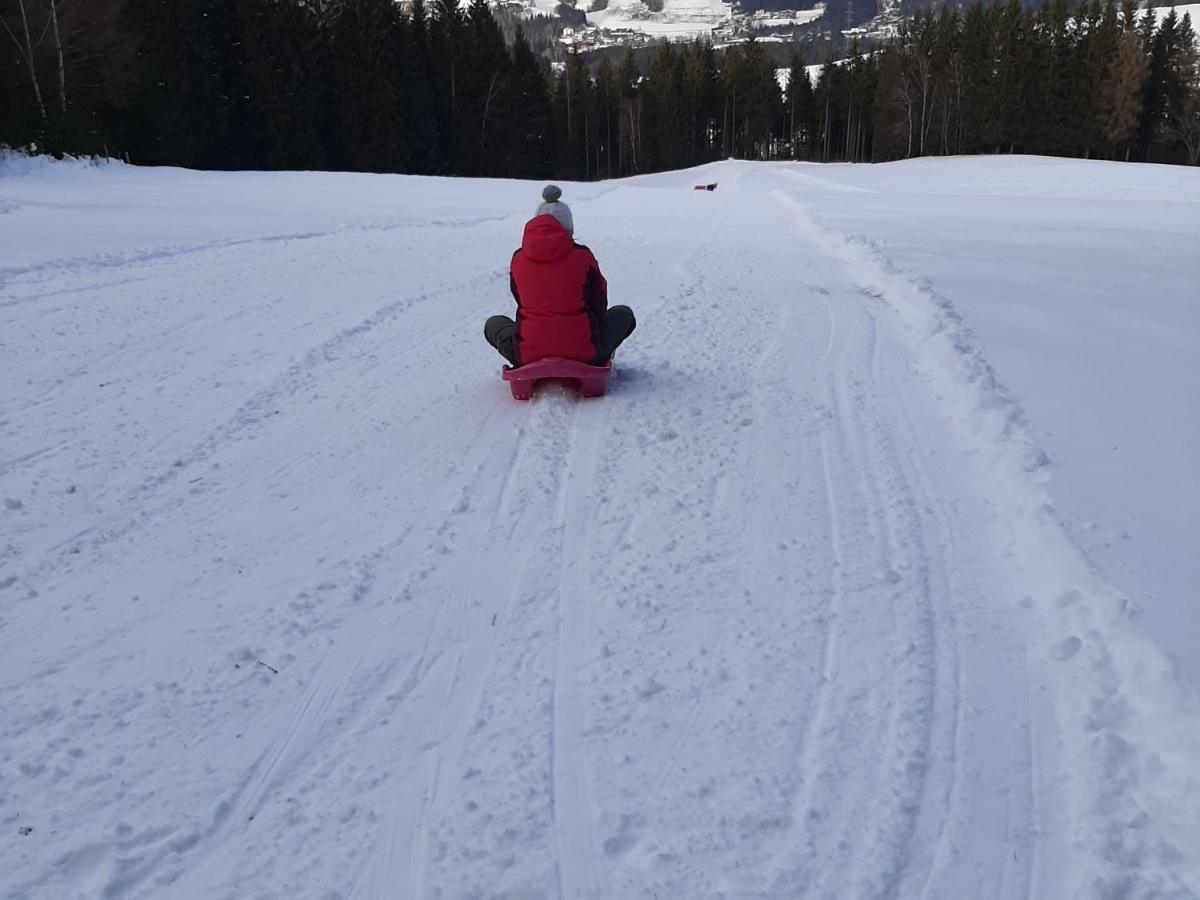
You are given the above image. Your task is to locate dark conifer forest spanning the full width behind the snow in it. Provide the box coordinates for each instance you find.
[0,0,1200,174]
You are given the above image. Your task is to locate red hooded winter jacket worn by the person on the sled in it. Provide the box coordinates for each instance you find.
[509,216,608,365]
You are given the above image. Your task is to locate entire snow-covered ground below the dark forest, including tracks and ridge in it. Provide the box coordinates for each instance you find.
[0,158,1200,900]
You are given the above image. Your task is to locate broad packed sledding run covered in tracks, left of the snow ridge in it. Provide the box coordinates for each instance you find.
[0,166,1187,900]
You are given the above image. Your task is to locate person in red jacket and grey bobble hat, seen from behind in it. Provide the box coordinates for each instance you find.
[484,185,637,367]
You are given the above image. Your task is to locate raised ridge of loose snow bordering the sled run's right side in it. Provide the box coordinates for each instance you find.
[772,188,1200,896]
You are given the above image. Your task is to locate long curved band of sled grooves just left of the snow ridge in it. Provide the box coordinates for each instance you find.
[777,194,1036,896]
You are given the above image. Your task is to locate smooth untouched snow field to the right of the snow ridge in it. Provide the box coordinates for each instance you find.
[758,157,1200,689]
